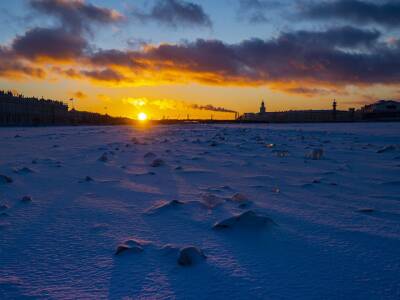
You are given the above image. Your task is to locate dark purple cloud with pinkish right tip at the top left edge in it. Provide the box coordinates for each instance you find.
[29,0,123,32]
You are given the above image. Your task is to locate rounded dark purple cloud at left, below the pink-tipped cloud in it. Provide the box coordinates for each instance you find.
[12,28,87,60]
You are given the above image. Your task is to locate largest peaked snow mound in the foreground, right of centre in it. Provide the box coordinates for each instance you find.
[213,210,276,229]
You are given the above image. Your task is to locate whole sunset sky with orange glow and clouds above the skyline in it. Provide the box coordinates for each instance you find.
[0,0,400,119]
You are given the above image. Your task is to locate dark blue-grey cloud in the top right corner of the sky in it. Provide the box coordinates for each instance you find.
[303,0,400,26]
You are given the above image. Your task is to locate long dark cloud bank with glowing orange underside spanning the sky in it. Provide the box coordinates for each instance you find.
[3,22,400,94]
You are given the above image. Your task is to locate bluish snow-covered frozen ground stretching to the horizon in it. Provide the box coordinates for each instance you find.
[0,123,400,300]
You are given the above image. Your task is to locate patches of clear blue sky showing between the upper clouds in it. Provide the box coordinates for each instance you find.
[0,0,292,48]
